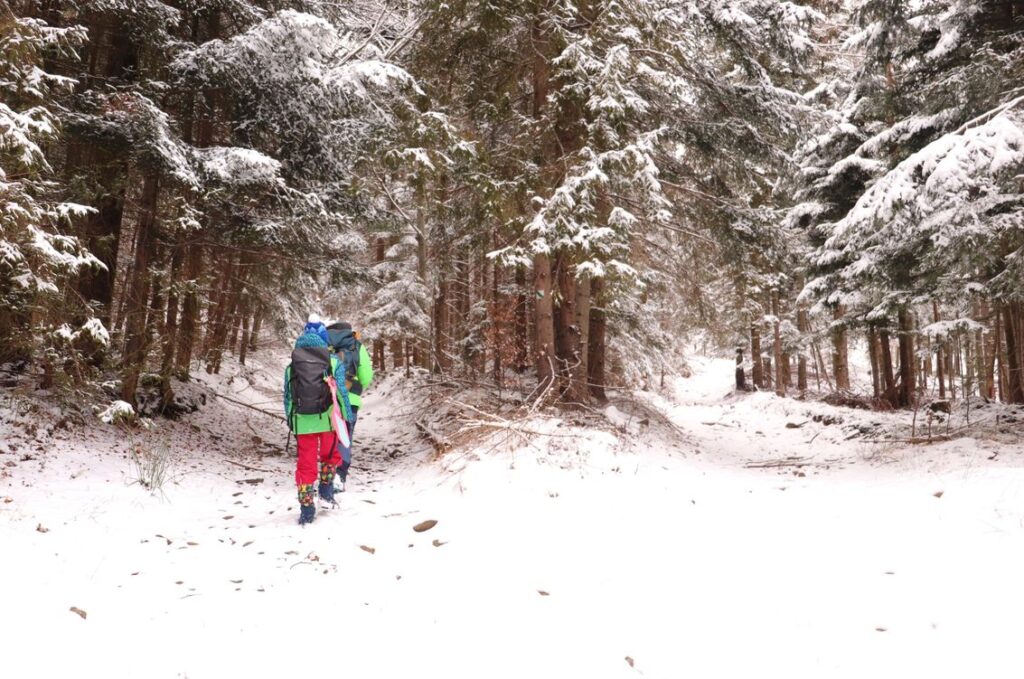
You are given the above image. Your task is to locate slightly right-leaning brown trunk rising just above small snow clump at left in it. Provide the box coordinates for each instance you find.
[121,173,160,406]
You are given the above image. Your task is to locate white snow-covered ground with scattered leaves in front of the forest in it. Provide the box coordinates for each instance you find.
[0,359,1024,679]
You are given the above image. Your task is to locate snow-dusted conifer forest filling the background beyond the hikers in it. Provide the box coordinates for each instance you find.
[0,0,1024,411]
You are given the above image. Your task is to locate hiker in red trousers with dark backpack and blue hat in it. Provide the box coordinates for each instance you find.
[285,315,355,524]
